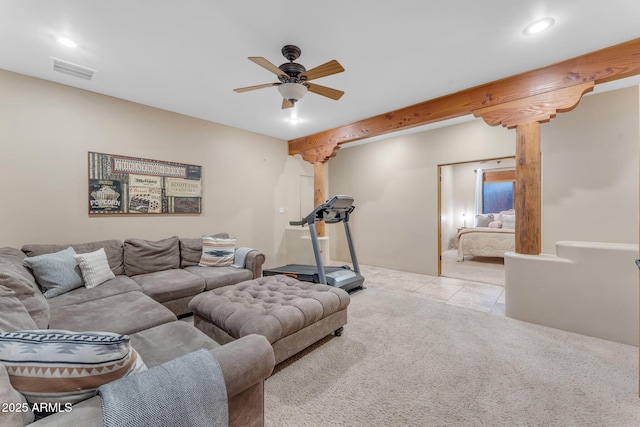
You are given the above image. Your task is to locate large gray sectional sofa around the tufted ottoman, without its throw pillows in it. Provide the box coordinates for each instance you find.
[0,237,275,426]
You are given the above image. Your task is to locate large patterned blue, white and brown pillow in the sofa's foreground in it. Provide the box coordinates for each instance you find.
[0,329,146,412]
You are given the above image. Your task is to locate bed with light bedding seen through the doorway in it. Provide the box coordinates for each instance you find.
[456,227,516,262]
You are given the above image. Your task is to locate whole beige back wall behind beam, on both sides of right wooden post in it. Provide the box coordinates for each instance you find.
[329,87,639,275]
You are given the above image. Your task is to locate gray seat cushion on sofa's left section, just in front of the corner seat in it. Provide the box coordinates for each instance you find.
[50,292,177,334]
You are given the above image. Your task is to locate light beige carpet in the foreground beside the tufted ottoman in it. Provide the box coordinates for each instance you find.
[265,288,640,427]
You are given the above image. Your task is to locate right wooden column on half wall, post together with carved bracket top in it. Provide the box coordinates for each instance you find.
[473,82,593,255]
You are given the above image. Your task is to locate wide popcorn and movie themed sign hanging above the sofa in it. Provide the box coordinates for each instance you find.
[89,152,202,215]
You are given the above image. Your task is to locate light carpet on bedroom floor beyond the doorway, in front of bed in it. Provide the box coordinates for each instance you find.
[442,249,504,286]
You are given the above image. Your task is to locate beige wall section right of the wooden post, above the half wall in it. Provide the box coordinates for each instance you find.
[541,86,640,254]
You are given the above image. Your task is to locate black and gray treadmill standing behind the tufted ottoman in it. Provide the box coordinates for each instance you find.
[262,195,364,292]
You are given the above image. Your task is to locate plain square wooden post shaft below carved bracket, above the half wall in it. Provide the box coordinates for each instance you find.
[514,122,542,255]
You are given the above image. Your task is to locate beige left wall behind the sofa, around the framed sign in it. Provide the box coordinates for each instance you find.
[0,70,313,266]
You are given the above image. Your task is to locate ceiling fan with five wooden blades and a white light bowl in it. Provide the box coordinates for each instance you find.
[233,44,344,109]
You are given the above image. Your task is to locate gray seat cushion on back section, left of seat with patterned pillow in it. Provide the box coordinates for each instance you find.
[131,270,205,302]
